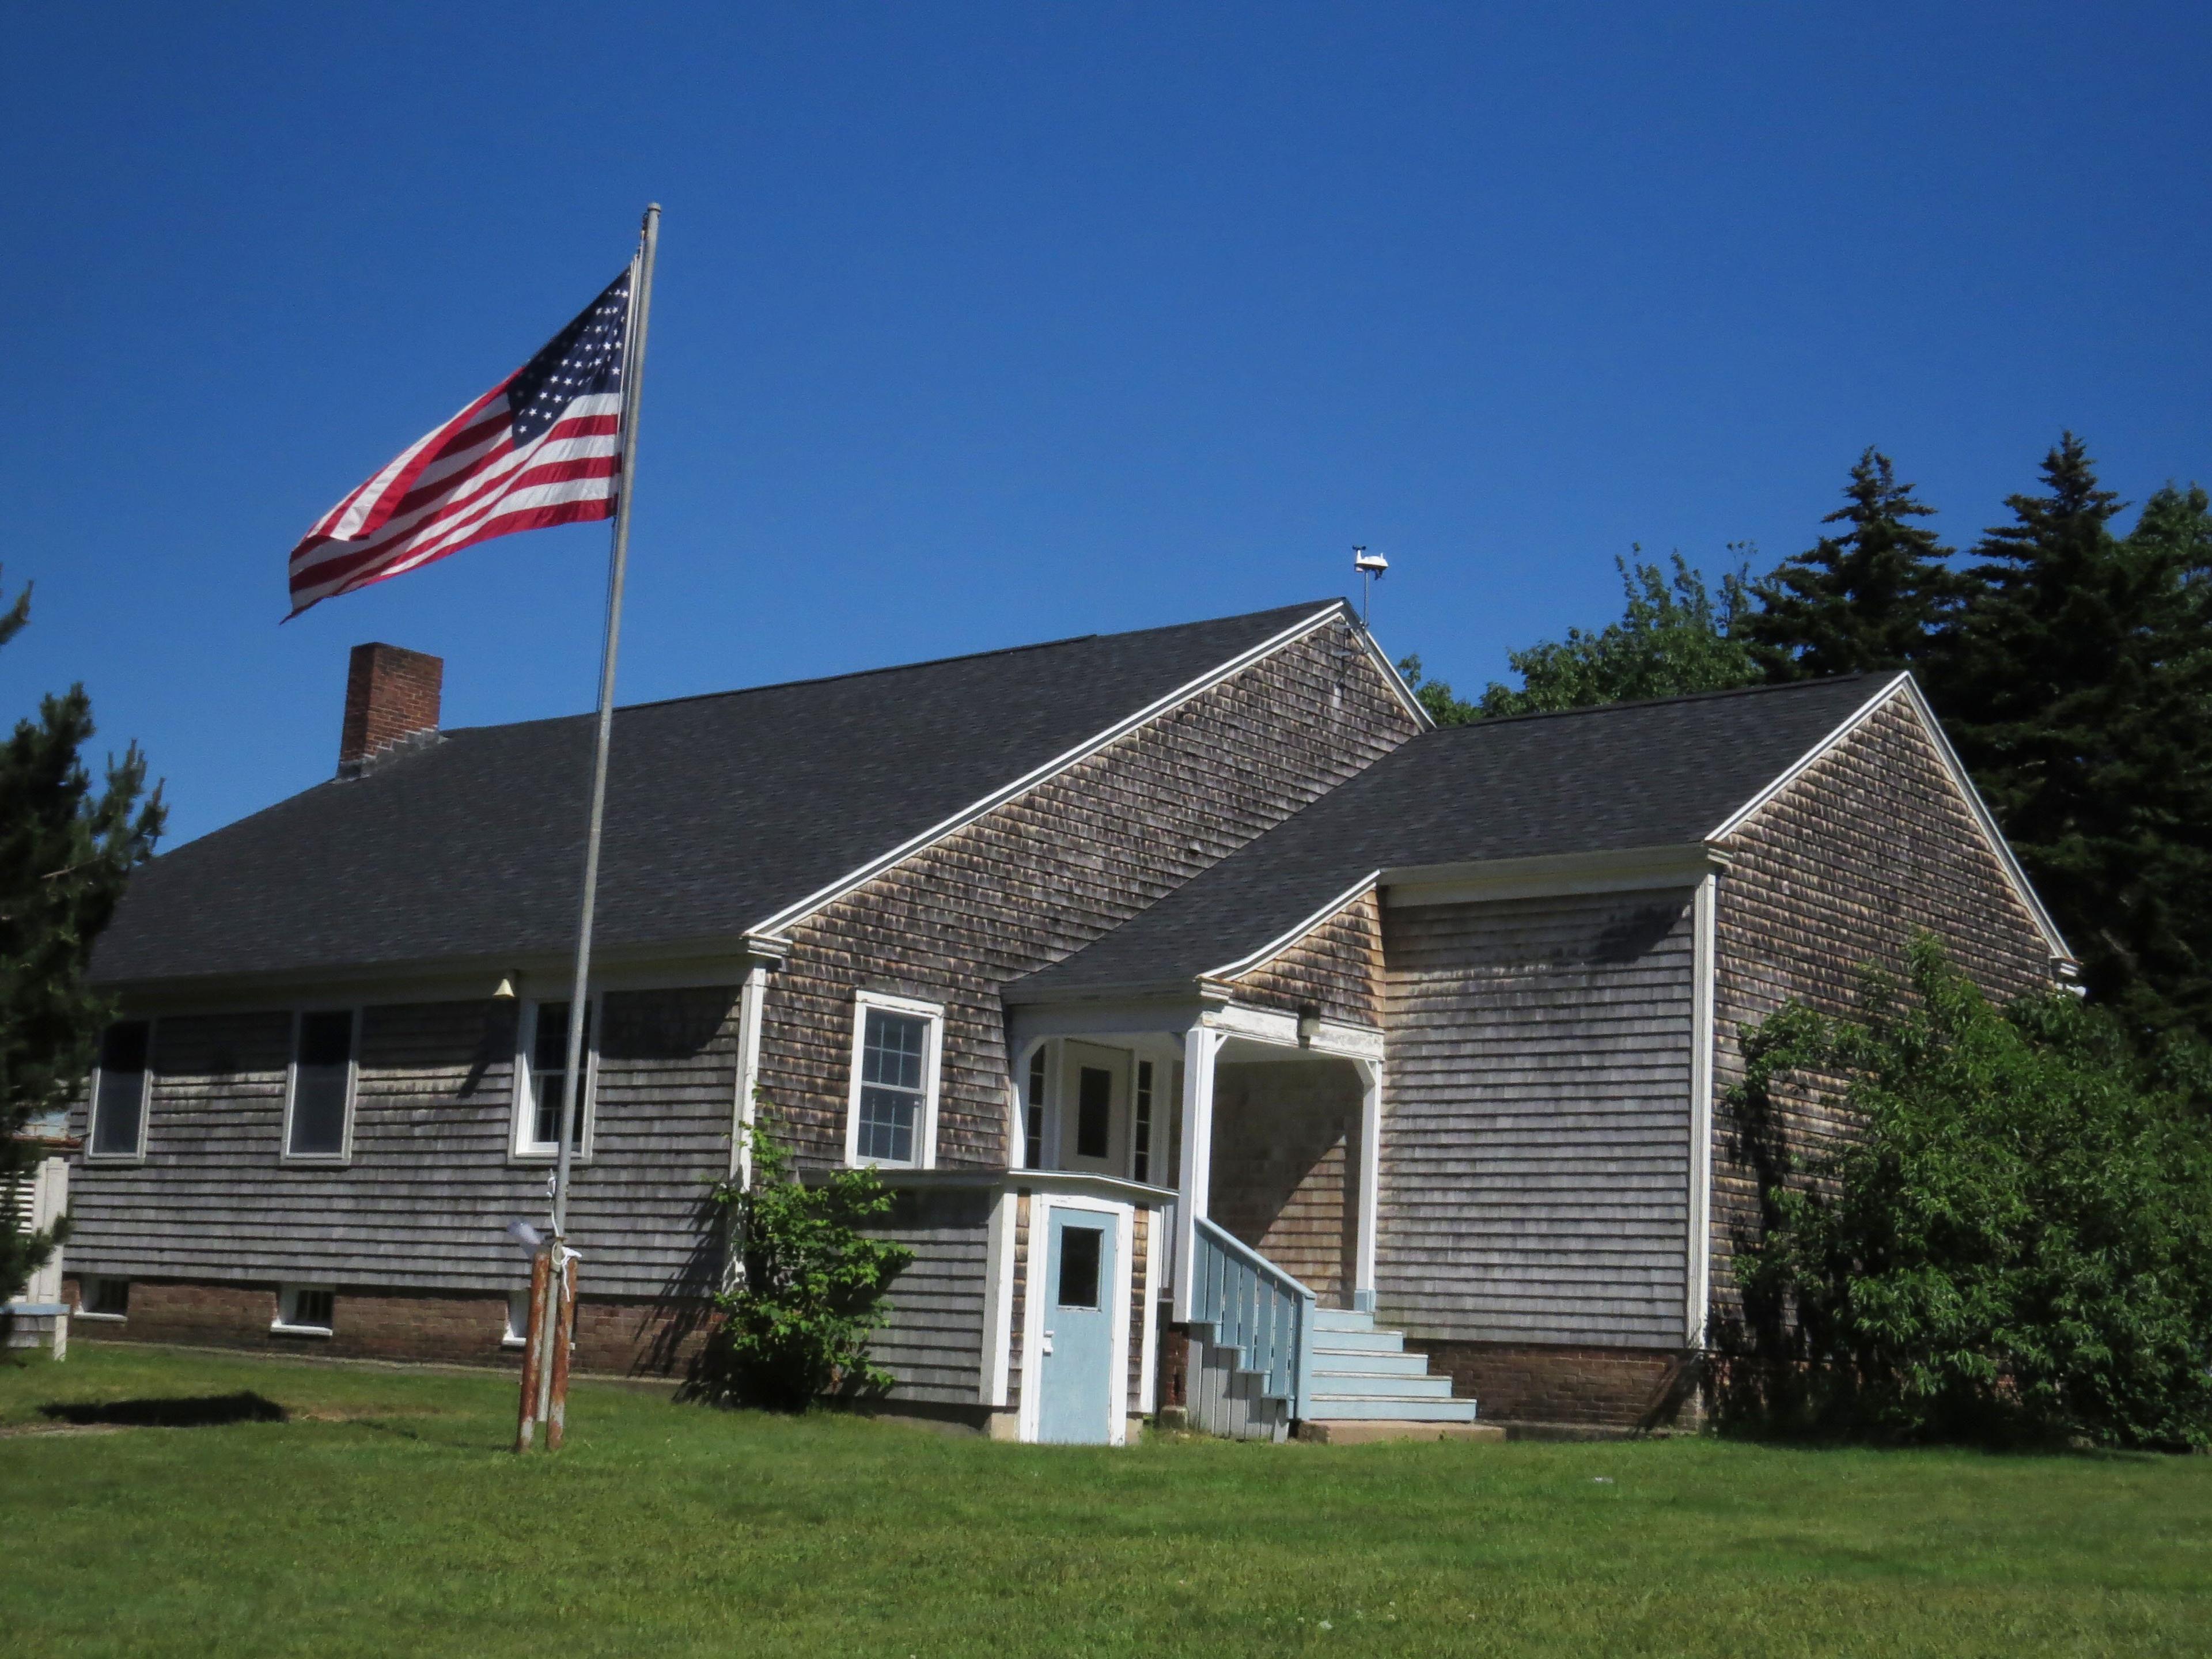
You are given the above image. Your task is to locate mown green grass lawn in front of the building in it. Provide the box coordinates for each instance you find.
[0,1343,2212,1659]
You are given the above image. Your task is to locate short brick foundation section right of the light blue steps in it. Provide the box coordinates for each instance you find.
[1404,1336,1703,1429]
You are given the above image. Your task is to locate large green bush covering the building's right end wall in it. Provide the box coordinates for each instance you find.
[1723,938,2212,1446]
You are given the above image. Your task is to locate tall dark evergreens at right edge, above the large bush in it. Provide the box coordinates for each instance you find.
[1929,434,2212,1037]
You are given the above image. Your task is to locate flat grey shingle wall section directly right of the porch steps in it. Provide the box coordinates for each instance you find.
[1376,893,1692,1347]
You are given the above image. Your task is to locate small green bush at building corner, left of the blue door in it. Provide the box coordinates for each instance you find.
[690,1126,914,1411]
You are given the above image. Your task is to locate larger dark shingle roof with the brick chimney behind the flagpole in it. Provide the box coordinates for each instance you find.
[93,600,1334,984]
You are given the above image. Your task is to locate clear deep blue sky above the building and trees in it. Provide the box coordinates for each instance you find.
[0,2,2212,845]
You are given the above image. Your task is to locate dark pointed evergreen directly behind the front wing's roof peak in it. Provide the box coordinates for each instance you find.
[1743,447,1962,679]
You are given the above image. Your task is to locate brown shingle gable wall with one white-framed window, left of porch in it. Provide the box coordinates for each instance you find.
[761,619,1416,1168]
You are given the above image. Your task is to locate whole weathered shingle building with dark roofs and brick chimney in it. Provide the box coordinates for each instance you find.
[69,601,2070,1442]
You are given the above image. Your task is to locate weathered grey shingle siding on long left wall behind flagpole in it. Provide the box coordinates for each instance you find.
[69,988,737,1296]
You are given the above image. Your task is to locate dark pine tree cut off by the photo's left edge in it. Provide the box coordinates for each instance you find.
[0,588,164,1301]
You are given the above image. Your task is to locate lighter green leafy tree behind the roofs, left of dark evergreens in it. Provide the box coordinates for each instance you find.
[1446,546,1761,714]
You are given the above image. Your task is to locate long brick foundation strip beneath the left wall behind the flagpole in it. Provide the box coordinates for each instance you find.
[62,1279,706,1376]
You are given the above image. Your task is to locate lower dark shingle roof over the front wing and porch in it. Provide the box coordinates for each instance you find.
[1009,675,1883,1002]
